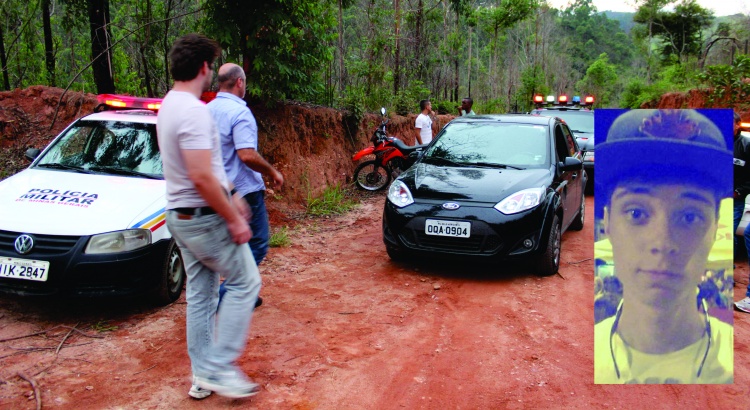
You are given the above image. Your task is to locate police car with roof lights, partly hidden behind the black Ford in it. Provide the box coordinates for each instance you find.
[531,94,594,192]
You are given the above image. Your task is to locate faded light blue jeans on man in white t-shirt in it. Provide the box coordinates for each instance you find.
[167,211,261,377]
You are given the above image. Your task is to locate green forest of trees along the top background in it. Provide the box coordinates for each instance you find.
[0,0,750,115]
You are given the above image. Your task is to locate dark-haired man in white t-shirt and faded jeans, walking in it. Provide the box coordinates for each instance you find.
[156,34,261,399]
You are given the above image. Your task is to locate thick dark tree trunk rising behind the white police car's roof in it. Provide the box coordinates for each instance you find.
[88,0,115,94]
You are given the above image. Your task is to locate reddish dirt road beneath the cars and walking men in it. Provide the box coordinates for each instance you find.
[0,196,750,409]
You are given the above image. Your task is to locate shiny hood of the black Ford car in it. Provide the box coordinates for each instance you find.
[402,162,552,204]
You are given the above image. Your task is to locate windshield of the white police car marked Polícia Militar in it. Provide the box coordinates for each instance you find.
[36,120,163,178]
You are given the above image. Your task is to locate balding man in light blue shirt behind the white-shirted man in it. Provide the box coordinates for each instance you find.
[208,63,284,307]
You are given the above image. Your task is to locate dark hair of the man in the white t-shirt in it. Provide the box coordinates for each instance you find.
[169,33,221,81]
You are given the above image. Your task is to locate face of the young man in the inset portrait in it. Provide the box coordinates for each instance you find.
[604,182,717,308]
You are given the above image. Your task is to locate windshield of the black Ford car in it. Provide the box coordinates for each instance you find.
[424,122,549,168]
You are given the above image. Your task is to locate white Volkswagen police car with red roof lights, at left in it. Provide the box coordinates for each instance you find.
[0,95,185,304]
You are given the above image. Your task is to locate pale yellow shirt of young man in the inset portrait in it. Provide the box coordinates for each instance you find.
[594,316,734,384]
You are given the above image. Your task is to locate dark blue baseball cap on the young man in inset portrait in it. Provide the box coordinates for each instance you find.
[595,109,733,197]
